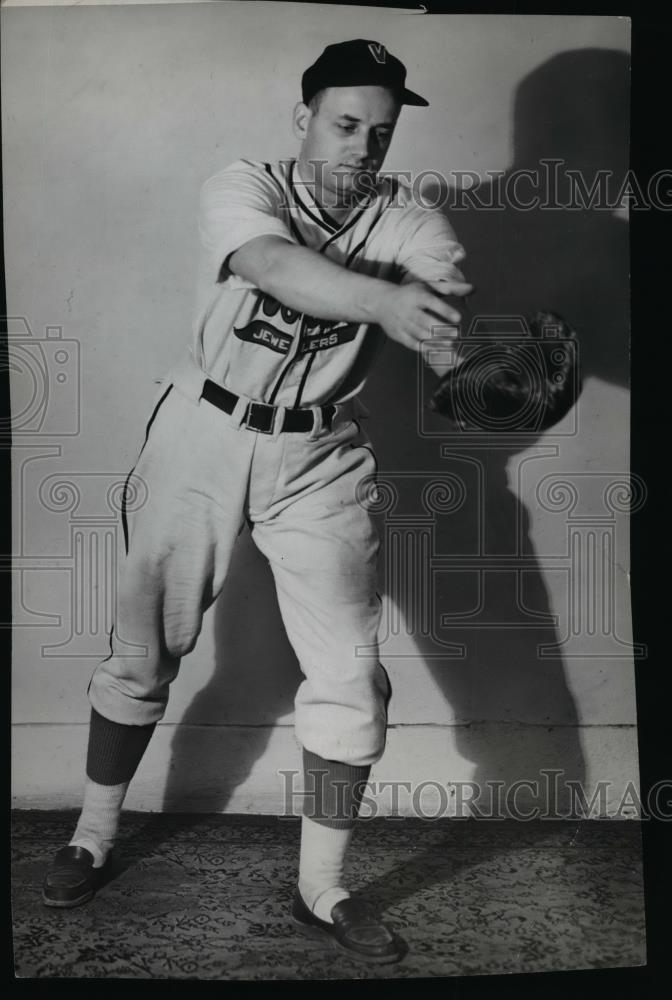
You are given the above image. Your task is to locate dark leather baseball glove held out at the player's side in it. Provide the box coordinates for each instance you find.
[429,312,581,433]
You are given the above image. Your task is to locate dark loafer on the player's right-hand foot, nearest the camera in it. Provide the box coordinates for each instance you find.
[292,889,404,962]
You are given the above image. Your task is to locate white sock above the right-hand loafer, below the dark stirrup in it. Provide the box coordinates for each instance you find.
[299,816,352,924]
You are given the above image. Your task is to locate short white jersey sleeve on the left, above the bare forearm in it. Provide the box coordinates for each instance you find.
[198,160,295,280]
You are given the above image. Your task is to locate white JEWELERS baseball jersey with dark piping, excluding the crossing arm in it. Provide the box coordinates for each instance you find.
[193,159,464,407]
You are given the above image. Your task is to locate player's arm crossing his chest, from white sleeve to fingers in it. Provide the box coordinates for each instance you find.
[199,161,471,350]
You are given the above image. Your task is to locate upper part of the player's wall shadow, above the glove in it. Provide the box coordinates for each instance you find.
[440,49,630,386]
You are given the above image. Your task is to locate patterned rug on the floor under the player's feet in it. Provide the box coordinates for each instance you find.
[13,812,645,980]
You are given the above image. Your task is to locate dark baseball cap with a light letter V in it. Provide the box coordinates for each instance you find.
[301,38,429,107]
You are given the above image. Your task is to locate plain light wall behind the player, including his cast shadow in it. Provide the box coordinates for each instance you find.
[2,3,637,812]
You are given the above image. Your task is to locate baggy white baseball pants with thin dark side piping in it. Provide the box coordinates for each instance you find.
[89,352,390,765]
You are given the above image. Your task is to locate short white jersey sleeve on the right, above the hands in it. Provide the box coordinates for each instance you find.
[395,208,466,284]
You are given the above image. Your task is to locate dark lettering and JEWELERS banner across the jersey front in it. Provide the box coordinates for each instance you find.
[233,294,359,354]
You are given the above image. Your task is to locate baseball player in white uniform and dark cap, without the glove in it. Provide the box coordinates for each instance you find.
[43,39,471,962]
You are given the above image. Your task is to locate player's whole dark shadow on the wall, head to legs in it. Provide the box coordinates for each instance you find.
[158,49,629,812]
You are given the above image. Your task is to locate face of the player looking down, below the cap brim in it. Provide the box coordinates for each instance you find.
[294,86,401,207]
